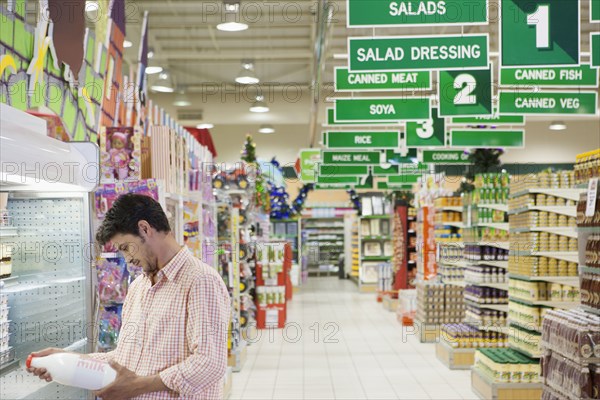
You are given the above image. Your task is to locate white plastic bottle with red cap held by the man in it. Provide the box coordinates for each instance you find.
[25,353,117,390]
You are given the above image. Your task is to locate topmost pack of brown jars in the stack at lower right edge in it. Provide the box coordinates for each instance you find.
[541,310,600,364]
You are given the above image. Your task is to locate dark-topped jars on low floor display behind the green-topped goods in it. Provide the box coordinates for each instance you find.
[441,324,507,349]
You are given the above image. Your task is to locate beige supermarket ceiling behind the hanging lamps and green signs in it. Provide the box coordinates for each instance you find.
[125,0,599,162]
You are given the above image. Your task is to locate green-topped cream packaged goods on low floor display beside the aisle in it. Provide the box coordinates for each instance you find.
[475,349,542,383]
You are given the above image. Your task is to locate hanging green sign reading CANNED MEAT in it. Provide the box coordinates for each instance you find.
[335,67,431,92]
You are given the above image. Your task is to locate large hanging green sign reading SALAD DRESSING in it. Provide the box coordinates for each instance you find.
[348,34,489,72]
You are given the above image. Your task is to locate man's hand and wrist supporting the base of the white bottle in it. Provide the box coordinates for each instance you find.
[94,361,170,400]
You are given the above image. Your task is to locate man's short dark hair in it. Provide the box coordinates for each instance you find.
[96,193,171,245]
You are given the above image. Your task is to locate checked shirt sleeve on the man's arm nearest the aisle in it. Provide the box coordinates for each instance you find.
[160,275,231,396]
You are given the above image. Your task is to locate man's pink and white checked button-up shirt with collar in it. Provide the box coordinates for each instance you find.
[91,247,230,400]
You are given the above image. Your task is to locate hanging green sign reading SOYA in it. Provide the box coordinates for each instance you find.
[335,97,431,122]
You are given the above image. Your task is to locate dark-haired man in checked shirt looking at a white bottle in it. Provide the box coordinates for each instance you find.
[28,194,230,400]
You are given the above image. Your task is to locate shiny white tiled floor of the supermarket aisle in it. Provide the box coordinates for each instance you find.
[230,278,477,400]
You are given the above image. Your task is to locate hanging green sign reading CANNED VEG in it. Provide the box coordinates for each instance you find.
[500,91,598,115]
